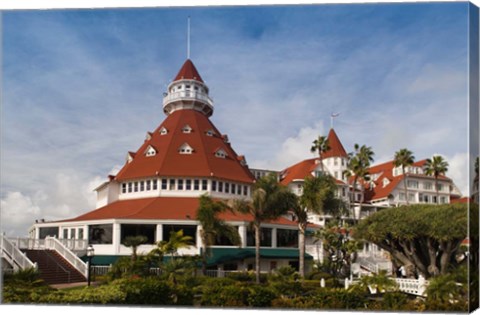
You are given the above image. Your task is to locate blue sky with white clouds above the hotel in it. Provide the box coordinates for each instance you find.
[1,3,468,235]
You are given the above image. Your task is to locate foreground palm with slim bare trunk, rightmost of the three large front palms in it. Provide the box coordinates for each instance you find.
[292,174,343,278]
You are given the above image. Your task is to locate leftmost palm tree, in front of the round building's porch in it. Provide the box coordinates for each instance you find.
[197,195,240,275]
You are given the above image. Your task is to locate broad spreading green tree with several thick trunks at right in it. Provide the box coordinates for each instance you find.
[355,203,468,278]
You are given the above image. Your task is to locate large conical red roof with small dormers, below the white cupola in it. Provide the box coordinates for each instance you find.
[116,109,254,183]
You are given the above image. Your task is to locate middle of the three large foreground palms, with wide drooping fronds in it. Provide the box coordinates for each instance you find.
[232,174,296,283]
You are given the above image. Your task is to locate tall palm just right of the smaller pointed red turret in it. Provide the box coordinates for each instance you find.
[344,143,375,221]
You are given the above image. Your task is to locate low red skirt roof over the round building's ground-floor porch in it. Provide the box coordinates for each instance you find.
[57,197,297,225]
